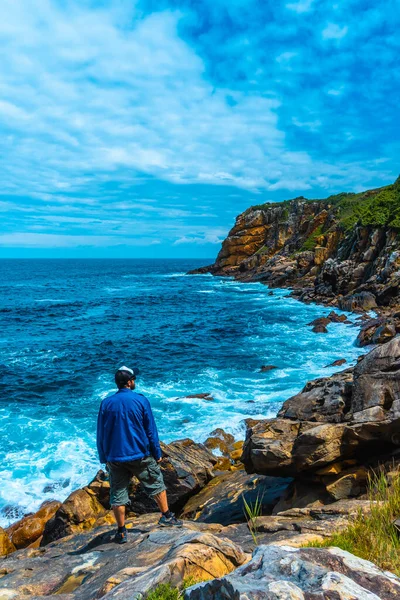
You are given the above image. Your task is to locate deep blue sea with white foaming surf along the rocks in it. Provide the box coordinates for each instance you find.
[0,259,362,527]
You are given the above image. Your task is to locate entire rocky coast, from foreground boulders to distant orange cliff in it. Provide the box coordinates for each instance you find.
[0,180,400,600]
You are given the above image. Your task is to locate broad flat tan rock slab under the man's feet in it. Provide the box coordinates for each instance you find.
[0,515,248,600]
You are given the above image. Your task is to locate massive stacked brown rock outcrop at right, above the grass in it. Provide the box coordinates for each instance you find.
[242,337,400,499]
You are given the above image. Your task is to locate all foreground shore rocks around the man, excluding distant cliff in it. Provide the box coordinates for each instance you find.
[0,337,400,600]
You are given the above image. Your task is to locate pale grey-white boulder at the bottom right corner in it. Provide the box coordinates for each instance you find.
[184,545,400,600]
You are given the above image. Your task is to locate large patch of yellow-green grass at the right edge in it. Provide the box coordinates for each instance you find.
[309,471,400,576]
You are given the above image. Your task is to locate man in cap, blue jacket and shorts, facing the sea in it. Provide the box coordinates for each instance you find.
[97,367,182,544]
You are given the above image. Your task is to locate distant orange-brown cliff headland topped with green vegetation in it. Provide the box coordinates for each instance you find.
[199,178,400,308]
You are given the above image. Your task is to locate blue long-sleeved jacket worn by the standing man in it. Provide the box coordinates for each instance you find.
[97,388,162,463]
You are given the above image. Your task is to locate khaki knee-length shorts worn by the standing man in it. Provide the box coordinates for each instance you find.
[107,456,166,506]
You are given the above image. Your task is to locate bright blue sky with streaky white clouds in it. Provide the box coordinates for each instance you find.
[0,0,400,258]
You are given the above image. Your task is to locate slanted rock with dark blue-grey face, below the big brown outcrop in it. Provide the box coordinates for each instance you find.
[181,471,291,525]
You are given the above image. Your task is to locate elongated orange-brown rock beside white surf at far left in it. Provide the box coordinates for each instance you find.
[7,500,61,549]
